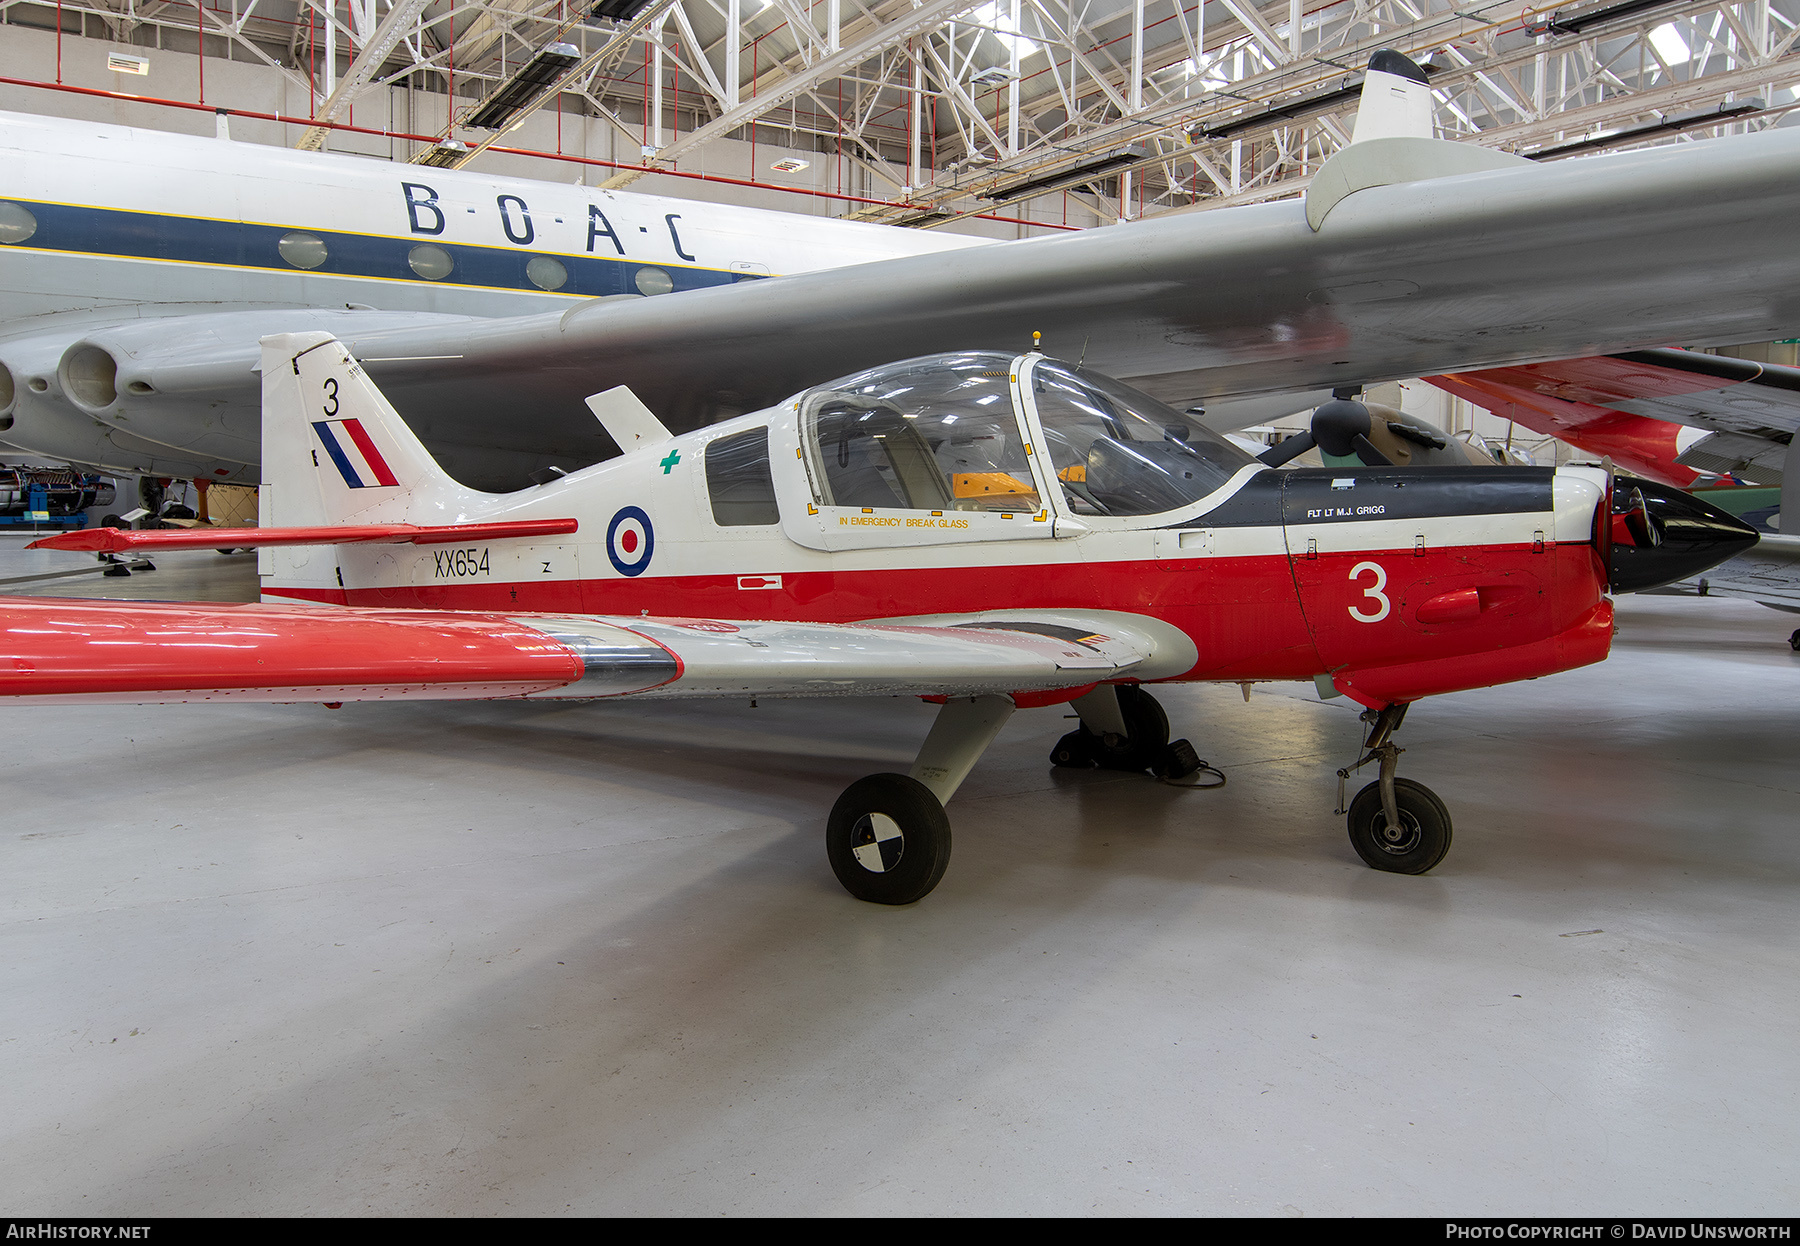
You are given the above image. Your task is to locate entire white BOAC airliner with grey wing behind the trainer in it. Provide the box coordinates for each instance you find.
[0,52,1800,490]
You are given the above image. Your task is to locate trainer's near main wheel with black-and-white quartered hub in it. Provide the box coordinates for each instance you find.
[824,774,950,904]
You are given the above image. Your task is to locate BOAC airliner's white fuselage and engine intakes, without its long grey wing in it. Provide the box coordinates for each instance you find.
[0,105,983,483]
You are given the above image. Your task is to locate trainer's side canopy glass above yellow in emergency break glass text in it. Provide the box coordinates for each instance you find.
[801,351,1040,511]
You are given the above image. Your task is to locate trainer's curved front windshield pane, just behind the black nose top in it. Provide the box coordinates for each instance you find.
[1031,360,1255,515]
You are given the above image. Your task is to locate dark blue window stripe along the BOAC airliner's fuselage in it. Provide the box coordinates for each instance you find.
[0,200,752,299]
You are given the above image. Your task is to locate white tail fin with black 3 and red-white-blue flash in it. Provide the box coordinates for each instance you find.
[261,331,470,528]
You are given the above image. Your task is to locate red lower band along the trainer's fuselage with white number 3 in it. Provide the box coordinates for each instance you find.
[270,544,1602,695]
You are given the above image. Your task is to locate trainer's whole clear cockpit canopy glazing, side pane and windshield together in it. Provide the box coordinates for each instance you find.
[799,351,1253,515]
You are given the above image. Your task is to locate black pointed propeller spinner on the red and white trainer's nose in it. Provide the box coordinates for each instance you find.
[1609,474,1757,592]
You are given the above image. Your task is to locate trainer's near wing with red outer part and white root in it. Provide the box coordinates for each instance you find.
[0,598,1166,702]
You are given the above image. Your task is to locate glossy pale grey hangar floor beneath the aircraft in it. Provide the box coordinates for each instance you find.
[0,540,1800,1217]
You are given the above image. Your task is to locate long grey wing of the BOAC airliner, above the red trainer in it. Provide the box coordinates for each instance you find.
[35,130,1800,488]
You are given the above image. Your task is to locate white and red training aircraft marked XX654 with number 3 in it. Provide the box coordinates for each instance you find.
[0,331,1755,904]
